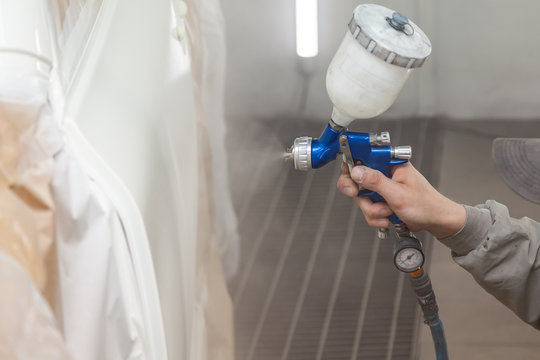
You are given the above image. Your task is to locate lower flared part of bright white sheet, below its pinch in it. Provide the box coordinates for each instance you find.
[52,106,167,360]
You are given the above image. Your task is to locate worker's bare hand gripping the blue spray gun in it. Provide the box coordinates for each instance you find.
[337,163,466,239]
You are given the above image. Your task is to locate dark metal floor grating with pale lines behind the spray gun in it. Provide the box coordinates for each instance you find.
[228,116,439,360]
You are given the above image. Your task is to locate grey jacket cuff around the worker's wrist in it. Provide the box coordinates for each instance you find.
[439,205,491,256]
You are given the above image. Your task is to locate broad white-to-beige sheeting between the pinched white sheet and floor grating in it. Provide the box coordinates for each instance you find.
[57,0,233,360]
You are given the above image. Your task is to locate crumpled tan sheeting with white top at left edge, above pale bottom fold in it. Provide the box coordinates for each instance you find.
[0,75,56,301]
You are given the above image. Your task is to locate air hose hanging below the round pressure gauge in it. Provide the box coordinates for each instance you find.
[409,268,448,360]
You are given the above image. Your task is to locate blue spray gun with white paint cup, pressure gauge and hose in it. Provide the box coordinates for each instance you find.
[286,4,448,360]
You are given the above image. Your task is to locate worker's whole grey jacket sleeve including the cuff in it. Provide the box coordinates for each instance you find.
[440,200,540,329]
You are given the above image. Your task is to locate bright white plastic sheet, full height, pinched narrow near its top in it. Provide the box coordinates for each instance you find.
[49,0,167,359]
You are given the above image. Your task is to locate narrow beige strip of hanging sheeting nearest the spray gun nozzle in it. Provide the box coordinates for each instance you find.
[186,1,238,359]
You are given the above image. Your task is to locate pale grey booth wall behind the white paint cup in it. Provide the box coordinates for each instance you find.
[222,0,540,119]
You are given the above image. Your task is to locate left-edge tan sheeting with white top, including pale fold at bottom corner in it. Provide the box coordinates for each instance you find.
[0,71,70,360]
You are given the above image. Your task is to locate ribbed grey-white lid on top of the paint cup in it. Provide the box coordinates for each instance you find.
[349,4,431,69]
